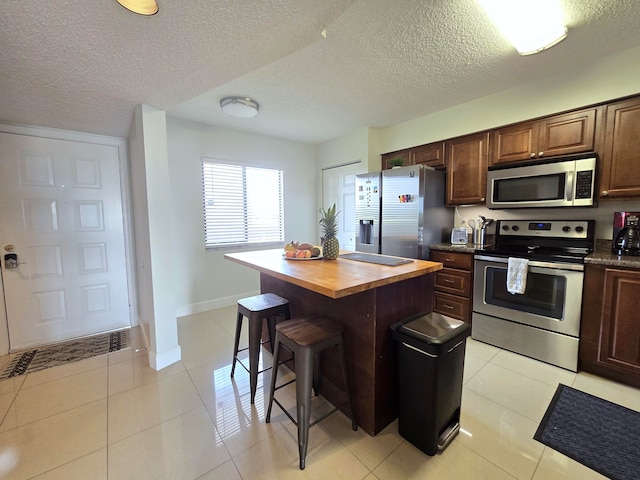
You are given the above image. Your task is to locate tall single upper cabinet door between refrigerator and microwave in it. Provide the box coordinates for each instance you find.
[446,132,489,205]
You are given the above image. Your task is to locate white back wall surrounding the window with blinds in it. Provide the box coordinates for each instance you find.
[167,117,319,316]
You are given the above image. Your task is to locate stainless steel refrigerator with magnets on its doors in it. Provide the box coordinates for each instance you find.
[356,165,453,259]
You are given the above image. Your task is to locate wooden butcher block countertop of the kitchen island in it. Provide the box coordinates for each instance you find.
[225,249,442,298]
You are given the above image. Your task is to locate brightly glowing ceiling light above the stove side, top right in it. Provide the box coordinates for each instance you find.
[478,0,567,55]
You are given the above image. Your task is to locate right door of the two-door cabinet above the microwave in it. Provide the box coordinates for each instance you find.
[537,108,596,157]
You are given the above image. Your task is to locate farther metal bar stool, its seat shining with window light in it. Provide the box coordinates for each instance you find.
[231,293,291,404]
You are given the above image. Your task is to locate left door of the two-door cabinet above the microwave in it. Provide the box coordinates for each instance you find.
[491,122,538,165]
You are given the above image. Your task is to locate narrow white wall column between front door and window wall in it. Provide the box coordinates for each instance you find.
[129,105,181,370]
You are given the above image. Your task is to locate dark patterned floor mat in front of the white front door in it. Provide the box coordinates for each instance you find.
[0,330,131,379]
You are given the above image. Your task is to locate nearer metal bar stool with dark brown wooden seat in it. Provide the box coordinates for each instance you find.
[265,316,358,470]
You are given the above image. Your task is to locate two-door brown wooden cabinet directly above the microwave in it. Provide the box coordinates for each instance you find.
[490,108,598,165]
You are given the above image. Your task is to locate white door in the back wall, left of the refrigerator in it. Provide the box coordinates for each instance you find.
[322,162,366,251]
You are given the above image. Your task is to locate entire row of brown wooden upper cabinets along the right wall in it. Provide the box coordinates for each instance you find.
[381,96,640,201]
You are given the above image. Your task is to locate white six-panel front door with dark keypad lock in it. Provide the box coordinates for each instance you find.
[0,133,130,350]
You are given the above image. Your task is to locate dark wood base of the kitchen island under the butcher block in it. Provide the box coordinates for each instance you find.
[260,273,434,435]
